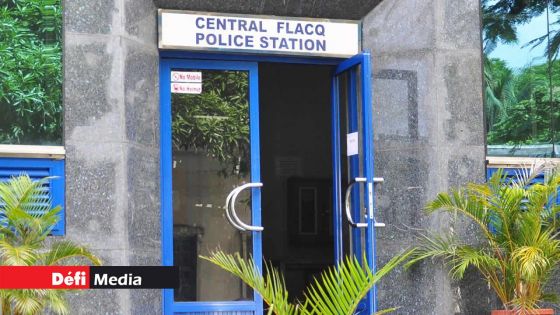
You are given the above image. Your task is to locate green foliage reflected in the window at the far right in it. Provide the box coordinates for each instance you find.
[484,57,560,144]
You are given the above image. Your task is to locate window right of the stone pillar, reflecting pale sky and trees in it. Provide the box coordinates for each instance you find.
[482,0,560,157]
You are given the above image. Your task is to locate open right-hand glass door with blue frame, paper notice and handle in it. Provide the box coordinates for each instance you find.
[332,53,383,315]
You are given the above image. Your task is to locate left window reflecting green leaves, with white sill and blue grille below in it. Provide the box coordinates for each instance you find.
[0,0,65,235]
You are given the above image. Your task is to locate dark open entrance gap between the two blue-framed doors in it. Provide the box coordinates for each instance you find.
[259,63,334,299]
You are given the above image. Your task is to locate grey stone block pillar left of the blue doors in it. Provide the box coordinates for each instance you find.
[64,0,161,314]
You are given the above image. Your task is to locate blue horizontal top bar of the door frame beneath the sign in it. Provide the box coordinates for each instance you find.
[159,50,344,66]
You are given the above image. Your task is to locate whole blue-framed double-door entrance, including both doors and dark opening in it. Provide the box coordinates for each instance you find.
[160,53,377,315]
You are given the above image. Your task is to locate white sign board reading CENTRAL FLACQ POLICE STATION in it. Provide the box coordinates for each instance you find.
[159,9,361,57]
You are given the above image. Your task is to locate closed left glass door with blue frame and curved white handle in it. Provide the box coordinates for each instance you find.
[160,60,262,315]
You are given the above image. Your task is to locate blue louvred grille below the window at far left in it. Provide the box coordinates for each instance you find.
[0,158,65,235]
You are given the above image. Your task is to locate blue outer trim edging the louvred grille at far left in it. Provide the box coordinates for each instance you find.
[0,158,66,236]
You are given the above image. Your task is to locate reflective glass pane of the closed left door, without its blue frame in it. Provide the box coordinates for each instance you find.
[171,69,252,301]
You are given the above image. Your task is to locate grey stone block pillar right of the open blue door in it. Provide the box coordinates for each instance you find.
[363,0,495,314]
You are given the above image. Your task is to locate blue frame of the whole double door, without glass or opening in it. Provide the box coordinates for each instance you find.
[160,51,377,315]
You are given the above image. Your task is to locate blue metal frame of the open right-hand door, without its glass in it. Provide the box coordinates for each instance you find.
[332,53,377,314]
